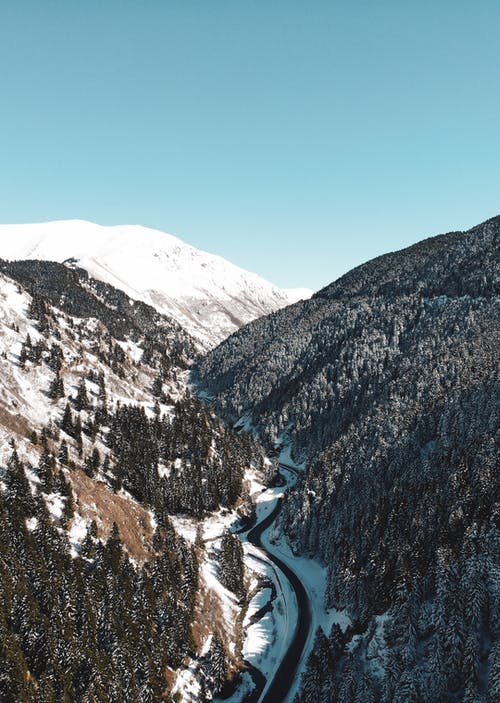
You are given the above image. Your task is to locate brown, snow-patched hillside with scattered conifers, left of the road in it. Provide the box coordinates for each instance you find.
[0,262,263,703]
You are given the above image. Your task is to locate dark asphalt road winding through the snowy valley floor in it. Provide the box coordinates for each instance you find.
[239,465,312,703]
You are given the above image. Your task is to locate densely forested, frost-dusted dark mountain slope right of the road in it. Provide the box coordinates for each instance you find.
[193,218,500,703]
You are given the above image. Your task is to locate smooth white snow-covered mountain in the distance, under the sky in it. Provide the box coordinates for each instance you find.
[0,220,311,348]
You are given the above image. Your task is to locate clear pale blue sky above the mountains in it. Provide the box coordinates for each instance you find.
[0,0,500,289]
